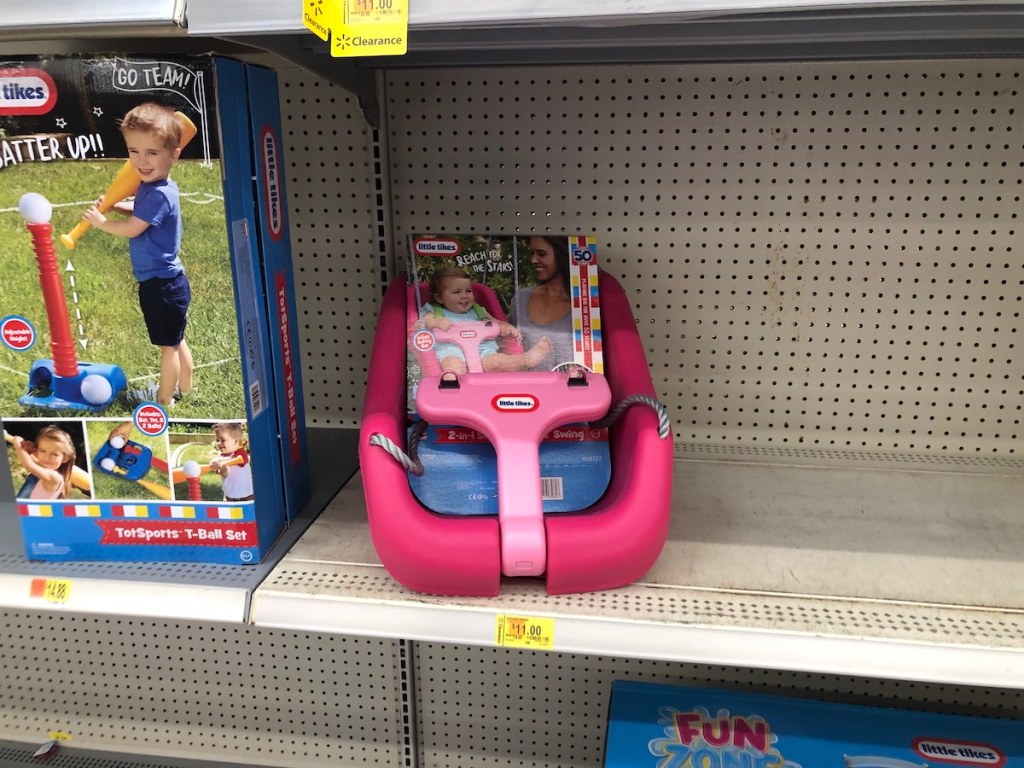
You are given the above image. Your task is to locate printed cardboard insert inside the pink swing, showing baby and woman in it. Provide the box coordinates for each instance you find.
[407,234,610,515]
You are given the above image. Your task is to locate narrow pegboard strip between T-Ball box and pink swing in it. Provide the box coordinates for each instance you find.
[279,70,381,427]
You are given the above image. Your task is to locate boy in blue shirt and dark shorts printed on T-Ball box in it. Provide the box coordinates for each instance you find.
[83,102,194,406]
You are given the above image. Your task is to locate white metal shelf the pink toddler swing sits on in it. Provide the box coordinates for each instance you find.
[251,452,1024,687]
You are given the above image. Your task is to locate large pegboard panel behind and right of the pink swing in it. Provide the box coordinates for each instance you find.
[387,59,1024,456]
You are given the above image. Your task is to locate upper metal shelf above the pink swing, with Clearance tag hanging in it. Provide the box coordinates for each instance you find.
[187,0,1024,67]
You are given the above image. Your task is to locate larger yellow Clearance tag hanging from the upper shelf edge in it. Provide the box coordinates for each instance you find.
[331,0,409,56]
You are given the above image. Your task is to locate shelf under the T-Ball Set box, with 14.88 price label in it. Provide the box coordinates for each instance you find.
[0,429,356,622]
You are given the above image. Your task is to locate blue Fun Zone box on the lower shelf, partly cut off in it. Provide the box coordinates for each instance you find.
[604,681,1024,768]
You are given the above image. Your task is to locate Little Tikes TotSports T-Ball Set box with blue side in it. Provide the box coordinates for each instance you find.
[0,56,309,563]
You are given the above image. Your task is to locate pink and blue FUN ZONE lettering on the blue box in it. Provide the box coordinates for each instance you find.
[647,707,800,768]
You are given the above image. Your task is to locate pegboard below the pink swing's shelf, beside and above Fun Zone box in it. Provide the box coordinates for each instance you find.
[415,643,1024,768]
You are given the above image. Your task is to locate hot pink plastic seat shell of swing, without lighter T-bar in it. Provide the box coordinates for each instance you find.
[359,272,672,596]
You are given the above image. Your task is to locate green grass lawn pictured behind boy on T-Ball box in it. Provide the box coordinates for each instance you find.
[0,160,245,419]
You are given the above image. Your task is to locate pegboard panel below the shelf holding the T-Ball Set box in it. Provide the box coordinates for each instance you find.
[0,611,406,768]
